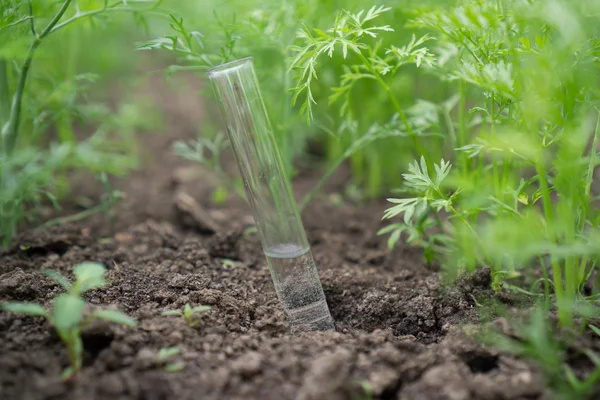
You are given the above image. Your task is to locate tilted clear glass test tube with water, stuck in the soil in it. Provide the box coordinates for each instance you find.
[208,57,334,333]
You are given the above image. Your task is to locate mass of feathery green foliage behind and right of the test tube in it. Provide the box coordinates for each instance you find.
[140,0,600,396]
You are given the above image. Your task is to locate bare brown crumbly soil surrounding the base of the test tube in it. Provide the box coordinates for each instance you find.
[0,73,580,400]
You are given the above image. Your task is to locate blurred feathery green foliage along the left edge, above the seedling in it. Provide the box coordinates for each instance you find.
[0,0,162,246]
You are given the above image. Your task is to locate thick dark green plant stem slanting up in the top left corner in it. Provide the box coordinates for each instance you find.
[2,0,72,154]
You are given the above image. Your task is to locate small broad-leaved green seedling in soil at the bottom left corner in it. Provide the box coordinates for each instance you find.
[2,262,136,379]
